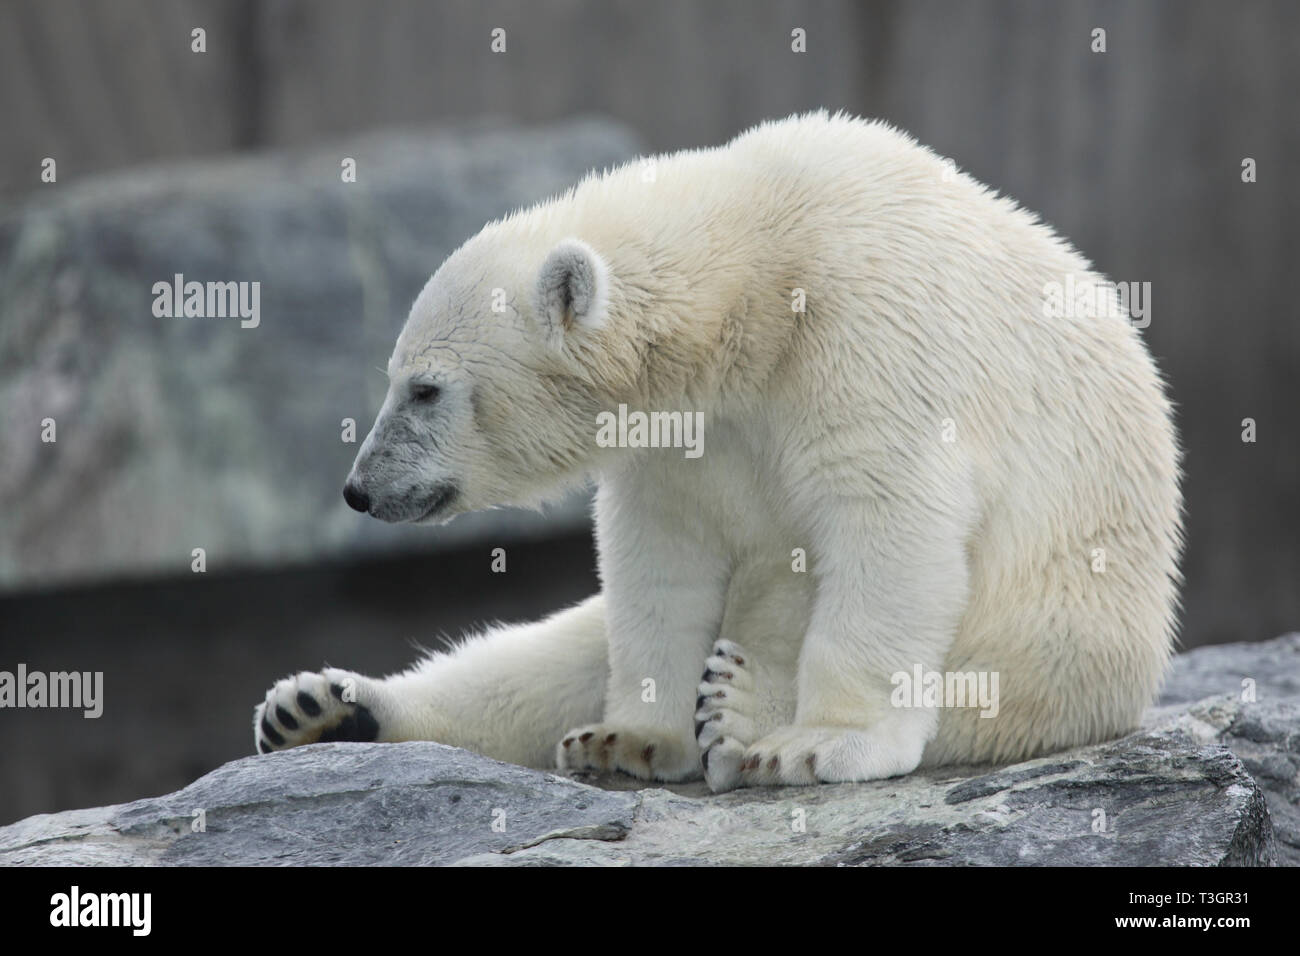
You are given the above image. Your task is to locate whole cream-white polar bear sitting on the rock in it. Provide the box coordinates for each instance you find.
[255,112,1182,791]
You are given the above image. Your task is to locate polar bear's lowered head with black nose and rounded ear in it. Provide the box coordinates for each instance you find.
[343,232,611,522]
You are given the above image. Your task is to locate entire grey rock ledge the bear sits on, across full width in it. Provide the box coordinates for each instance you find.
[0,635,1300,866]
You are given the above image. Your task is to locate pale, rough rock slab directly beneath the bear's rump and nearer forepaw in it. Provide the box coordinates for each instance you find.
[473,702,1277,866]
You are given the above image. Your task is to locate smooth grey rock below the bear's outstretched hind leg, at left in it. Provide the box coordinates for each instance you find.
[0,743,637,866]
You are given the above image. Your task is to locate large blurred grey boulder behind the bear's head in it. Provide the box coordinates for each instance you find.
[0,120,636,589]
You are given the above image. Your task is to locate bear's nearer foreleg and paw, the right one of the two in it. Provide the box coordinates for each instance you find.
[738,502,969,790]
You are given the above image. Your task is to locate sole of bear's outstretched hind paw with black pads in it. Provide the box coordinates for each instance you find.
[252,667,380,753]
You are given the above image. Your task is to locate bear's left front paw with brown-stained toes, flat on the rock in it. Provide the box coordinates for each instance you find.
[555,723,699,782]
